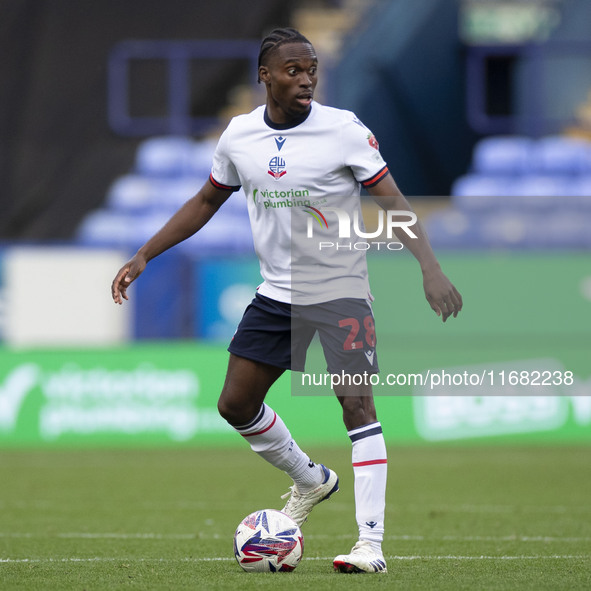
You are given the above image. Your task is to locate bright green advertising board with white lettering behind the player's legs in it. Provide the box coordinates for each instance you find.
[0,343,591,448]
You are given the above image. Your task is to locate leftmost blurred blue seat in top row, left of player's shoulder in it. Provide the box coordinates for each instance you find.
[135,136,195,176]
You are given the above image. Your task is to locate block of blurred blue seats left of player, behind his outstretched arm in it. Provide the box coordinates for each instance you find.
[77,136,253,256]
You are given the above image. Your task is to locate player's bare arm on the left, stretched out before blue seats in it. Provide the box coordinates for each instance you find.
[111,180,232,304]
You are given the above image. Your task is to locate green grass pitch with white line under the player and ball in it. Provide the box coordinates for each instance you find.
[0,441,591,591]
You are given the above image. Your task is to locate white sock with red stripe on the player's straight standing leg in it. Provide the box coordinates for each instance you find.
[347,422,388,553]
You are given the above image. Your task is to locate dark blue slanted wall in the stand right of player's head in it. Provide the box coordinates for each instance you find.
[331,0,476,196]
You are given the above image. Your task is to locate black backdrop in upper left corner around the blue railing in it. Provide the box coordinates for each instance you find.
[0,0,293,240]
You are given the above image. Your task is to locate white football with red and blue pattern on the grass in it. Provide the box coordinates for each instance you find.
[234,509,304,573]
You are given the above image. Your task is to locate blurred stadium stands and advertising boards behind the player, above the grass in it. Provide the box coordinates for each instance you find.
[0,0,591,447]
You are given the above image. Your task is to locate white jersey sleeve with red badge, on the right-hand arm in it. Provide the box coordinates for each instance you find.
[342,112,389,188]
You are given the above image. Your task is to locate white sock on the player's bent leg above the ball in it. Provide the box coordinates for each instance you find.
[234,404,325,492]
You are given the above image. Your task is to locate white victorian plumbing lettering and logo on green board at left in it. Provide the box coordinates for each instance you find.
[0,363,225,441]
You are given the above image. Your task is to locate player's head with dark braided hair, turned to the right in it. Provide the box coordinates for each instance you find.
[259,28,318,119]
